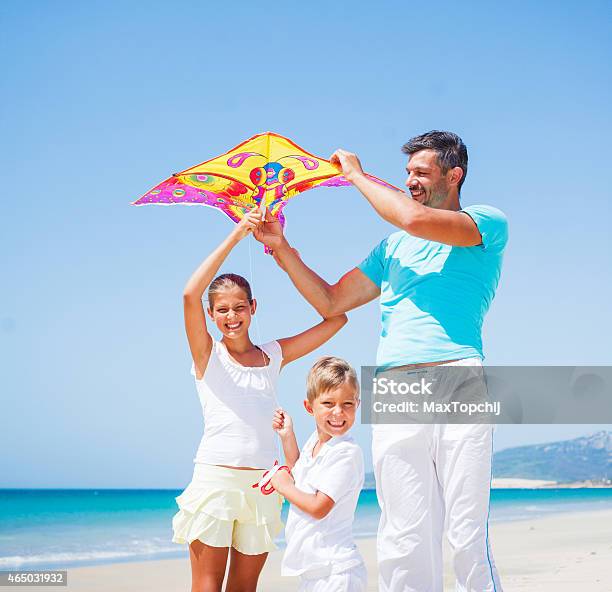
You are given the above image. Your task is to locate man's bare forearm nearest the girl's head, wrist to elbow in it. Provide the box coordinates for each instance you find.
[274,240,333,318]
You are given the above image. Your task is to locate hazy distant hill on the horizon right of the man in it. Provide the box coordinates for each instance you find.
[493,431,612,483]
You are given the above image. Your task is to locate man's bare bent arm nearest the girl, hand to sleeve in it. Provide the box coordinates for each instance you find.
[253,213,380,318]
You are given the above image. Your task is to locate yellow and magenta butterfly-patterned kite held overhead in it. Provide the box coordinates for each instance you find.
[132,132,397,231]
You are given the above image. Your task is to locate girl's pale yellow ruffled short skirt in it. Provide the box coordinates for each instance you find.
[172,464,283,555]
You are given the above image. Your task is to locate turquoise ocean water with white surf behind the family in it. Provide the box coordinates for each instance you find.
[0,488,612,570]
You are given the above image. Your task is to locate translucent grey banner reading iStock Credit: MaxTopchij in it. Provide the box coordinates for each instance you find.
[361,363,612,424]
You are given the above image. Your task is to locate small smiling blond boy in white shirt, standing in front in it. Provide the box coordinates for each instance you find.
[272,357,367,592]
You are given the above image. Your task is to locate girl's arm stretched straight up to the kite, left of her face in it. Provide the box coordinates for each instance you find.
[183,208,261,380]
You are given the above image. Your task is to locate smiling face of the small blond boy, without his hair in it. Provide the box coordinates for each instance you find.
[304,382,359,442]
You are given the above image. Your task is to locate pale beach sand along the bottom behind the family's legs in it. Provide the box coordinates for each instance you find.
[20,510,612,592]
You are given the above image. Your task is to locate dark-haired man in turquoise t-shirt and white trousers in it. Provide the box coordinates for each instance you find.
[255,131,507,592]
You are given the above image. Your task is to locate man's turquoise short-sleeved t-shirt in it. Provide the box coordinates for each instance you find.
[358,205,508,368]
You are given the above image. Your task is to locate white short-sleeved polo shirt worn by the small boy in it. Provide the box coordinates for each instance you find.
[281,432,364,578]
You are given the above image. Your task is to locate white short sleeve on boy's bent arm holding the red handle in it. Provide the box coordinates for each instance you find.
[311,445,364,502]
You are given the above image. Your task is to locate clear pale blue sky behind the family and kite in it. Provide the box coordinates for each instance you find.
[0,2,612,487]
